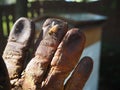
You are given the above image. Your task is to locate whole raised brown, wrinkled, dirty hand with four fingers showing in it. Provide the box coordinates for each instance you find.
[0,18,93,90]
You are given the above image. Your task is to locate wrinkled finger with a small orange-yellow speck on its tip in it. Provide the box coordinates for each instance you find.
[23,19,67,90]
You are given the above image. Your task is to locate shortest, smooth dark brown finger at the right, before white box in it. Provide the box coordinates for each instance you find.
[65,57,93,90]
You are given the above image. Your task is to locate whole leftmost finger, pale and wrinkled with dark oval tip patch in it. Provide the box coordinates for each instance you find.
[3,17,34,80]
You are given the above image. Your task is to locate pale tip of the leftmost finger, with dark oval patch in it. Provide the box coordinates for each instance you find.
[8,17,35,44]
